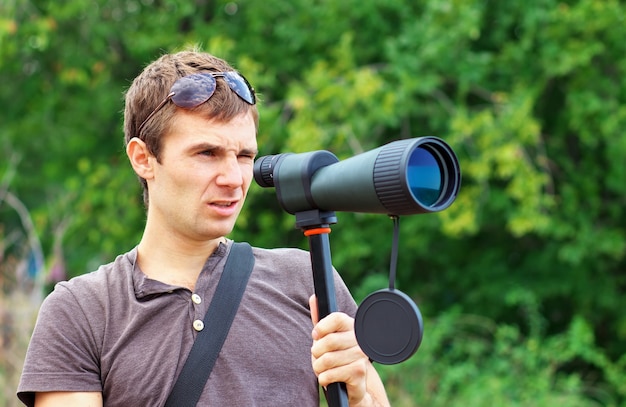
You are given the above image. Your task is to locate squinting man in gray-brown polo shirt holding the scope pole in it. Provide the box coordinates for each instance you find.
[18,51,388,407]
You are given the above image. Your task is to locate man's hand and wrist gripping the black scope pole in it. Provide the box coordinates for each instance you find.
[309,295,388,406]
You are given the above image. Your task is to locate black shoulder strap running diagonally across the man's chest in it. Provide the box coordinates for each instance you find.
[165,243,254,407]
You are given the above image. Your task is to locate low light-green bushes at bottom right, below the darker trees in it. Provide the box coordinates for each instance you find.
[379,310,626,407]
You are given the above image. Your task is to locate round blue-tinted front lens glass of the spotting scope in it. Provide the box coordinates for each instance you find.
[407,147,443,206]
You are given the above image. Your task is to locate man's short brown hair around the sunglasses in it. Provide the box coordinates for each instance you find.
[124,50,259,208]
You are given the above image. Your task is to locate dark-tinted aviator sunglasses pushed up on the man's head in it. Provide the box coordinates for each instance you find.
[137,71,256,135]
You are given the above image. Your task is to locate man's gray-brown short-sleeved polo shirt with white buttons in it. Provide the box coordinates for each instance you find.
[18,241,356,406]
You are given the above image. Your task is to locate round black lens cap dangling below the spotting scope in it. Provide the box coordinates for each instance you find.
[354,288,424,365]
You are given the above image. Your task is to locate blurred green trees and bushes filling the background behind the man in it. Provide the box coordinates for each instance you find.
[0,0,626,407]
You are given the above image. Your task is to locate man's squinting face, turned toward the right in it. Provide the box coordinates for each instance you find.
[148,111,257,242]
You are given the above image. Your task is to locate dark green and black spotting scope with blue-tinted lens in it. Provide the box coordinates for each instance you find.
[254,137,461,215]
